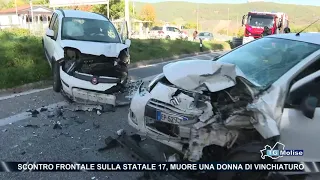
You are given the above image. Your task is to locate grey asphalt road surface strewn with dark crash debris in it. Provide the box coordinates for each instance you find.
[0,54,217,180]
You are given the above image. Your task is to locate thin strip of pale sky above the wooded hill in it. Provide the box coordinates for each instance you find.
[135,0,320,6]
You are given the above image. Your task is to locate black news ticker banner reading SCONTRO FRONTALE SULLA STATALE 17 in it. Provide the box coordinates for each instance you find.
[0,161,320,172]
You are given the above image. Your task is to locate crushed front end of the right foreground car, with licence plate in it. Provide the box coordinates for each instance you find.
[128,60,272,161]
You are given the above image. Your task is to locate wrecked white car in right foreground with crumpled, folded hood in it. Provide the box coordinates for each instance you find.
[128,33,320,180]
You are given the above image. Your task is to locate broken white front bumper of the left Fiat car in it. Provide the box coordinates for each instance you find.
[60,67,123,106]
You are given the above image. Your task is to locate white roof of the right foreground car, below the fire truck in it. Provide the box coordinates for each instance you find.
[267,32,320,45]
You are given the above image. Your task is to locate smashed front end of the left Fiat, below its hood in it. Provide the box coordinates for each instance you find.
[59,48,130,105]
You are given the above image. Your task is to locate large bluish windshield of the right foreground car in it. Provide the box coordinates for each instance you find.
[217,37,320,89]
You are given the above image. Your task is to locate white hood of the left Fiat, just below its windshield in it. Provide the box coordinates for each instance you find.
[61,40,128,57]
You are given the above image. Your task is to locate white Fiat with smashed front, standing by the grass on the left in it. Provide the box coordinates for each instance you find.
[42,10,131,105]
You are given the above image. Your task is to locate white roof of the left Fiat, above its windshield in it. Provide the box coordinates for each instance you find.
[55,9,109,21]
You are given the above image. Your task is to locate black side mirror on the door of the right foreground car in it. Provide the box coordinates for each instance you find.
[300,96,318,119]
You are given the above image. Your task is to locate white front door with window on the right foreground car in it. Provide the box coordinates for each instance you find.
[277,70,320,161]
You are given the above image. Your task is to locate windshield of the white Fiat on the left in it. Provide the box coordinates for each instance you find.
[61,17,121,43]
